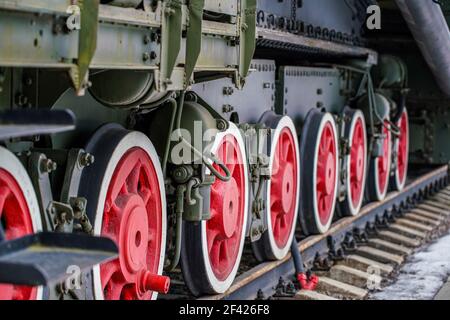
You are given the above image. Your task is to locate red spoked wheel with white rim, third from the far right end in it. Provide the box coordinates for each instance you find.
[342,110,367,216]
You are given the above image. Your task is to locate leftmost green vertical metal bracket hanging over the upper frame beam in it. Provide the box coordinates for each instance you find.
[70,0,99,94]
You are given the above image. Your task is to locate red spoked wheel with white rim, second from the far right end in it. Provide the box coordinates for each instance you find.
[367,120,392,201]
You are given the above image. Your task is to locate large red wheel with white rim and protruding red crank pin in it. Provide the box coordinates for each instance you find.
[80,126,170,300]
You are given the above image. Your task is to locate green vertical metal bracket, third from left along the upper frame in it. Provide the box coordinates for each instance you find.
[185,0,205,86]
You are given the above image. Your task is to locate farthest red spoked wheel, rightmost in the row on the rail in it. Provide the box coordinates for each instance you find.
[391,108,409,191]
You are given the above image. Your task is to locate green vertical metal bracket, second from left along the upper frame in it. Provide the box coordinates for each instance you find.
[160,0,183,90]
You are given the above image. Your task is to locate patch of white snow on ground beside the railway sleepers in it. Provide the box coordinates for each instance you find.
[370,234,450,300]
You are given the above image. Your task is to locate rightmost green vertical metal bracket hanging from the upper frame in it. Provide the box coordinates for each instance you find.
[237,0,256,87]
